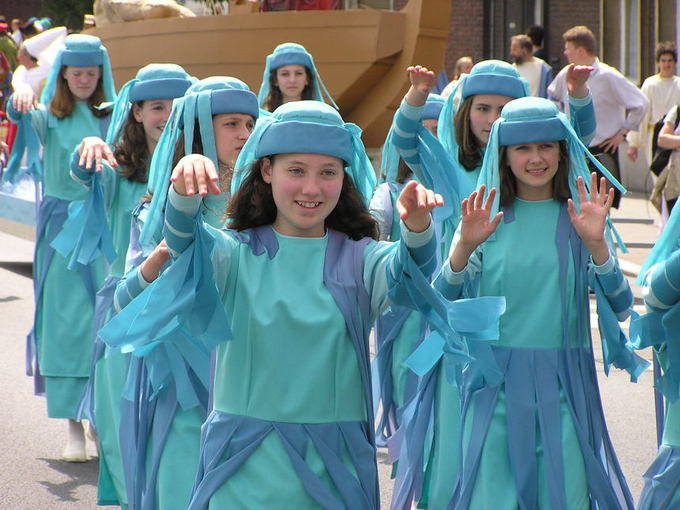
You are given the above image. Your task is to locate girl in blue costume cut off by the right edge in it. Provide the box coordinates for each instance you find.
[631,193,680,510]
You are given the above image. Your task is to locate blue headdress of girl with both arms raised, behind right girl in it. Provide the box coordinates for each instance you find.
[437,60,530,158]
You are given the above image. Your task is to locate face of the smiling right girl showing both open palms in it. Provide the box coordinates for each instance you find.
[507,142,560,200]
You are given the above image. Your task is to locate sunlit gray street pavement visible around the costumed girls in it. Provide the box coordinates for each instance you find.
[0,193,658,510]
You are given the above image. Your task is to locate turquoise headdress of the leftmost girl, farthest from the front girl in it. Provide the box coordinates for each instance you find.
[40,34,116,110]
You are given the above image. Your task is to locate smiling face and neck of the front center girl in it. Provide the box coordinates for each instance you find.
[261,154,345,237]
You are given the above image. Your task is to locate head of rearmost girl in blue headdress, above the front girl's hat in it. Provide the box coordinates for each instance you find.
[258,43,338,112]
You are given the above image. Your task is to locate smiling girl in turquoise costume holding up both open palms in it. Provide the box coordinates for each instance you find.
[432,94,648,510]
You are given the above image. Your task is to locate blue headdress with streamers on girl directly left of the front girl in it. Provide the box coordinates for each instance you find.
[140,76,260,249]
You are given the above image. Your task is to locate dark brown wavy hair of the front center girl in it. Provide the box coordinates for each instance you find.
[227,156,378,241]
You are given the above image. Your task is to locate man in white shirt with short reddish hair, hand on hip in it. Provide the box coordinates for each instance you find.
[548,26,649,207]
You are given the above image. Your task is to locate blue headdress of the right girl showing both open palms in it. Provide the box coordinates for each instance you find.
[477,97,626,231]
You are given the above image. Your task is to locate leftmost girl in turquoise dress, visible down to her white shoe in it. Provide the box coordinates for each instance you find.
[8,34,115,462]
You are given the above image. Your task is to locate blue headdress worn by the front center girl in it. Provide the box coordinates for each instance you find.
[231,101,376,205]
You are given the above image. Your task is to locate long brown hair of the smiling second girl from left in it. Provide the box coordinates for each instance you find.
[113,101,151,182]
